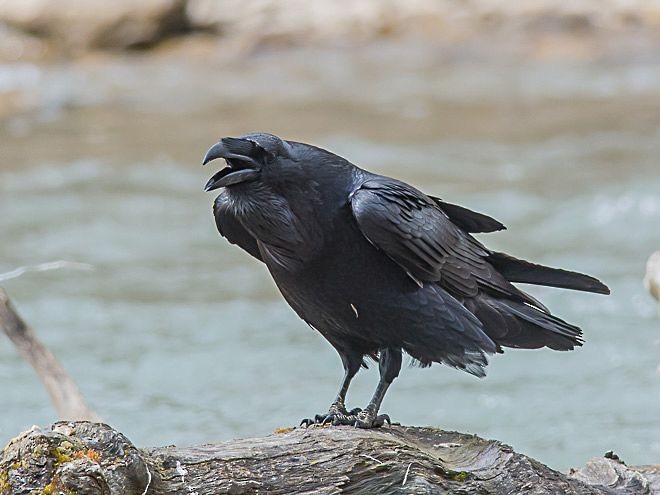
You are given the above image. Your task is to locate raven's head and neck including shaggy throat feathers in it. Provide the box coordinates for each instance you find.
[203,133,346,260]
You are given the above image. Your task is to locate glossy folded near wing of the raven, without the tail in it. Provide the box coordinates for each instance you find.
[351,177,535,304]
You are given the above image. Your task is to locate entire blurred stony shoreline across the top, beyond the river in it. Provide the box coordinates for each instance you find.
[0,0,660,62]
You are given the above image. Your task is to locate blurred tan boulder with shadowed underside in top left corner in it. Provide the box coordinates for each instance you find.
[0,0,187,53]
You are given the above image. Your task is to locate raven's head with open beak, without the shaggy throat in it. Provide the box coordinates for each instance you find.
[203,133,292,191]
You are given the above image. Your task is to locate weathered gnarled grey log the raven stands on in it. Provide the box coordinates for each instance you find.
[0,422,660,495]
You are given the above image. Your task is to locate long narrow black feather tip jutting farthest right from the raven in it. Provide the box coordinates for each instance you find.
[488,252,610,294]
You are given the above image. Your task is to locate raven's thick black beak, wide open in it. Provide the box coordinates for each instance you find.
[202,138,261,192]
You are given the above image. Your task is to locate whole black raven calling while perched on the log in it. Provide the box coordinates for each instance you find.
[204,133,609,428]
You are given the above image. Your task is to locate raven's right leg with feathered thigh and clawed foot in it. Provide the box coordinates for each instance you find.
[320,347,401,428]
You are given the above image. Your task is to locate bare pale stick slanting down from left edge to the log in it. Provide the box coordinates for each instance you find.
[0,289,99,421]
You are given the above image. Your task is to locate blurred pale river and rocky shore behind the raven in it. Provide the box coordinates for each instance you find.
[0,0,660,470]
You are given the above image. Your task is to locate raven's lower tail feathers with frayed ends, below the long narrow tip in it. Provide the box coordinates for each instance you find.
[465,294,583,351]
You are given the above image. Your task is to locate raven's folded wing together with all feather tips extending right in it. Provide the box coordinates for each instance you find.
[351,177,608,350]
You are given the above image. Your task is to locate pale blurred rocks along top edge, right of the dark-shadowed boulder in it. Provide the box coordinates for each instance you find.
[186,0,660,47]
